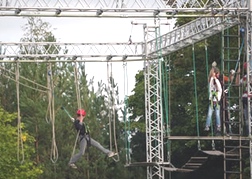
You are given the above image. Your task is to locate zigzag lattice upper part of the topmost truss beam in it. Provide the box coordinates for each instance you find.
[0,0,249,9]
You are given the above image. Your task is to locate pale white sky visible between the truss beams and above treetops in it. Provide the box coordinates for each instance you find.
[0,17,173,103]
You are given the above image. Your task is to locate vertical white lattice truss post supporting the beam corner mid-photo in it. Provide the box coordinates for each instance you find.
[144,20,164,179]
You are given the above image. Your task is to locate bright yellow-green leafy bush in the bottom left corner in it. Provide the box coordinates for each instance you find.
[0,108,42,179]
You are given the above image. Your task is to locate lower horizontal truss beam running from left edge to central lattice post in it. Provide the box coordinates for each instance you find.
[0,42,143,62]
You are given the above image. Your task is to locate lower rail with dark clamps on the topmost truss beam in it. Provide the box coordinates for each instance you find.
[0,7,248,18]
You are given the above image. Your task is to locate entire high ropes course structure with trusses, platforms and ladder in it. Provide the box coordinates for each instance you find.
[0,0,252,179]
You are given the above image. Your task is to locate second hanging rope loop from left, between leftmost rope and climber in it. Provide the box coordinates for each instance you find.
[47,63,59,163]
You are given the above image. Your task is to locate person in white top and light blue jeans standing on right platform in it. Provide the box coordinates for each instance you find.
[204,67,222,133]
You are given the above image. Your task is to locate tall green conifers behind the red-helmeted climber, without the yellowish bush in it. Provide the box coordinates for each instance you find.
[0,18,148,179]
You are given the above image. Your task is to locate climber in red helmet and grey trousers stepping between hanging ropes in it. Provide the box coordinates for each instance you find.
[69,109,116,169]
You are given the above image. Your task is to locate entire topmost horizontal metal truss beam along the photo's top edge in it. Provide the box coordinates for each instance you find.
[0,0,248,18]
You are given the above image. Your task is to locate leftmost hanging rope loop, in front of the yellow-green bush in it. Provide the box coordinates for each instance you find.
[16,62,24,164]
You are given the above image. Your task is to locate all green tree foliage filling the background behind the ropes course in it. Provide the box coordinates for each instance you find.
[0,14,249,179]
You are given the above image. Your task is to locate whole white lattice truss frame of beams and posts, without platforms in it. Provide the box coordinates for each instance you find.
[0,0,252,179]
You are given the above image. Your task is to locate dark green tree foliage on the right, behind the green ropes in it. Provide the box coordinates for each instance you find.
[129,18,249,178]
